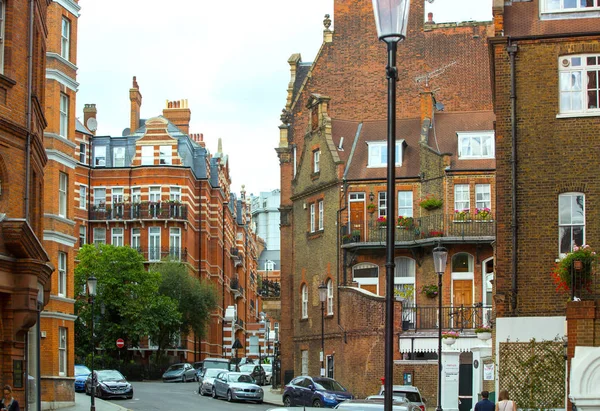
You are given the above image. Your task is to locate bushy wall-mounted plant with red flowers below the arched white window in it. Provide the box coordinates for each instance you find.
[552,244,598,292]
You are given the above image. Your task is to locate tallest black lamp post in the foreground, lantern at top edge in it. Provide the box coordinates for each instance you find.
[373,0,410,411]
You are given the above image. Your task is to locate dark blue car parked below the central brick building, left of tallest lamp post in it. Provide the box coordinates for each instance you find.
[282,375,354,408]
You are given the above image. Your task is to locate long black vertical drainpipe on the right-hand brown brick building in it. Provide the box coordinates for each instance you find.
[506,39,518,316]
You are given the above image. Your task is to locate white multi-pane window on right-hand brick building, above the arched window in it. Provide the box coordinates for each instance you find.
[558,54,600,115]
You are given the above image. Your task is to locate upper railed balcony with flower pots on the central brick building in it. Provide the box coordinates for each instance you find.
[341,214,496,247]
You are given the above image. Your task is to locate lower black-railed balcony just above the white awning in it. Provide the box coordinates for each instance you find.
[402,303,492,331]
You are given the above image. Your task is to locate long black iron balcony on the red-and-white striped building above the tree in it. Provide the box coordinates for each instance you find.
[90,201,187,221]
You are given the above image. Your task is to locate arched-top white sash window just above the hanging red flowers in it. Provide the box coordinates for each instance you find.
[558,193,585,255]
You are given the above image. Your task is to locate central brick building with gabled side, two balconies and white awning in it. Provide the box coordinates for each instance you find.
[277,0,496,409]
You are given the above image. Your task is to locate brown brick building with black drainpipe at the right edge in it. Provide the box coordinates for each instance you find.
[490,0,600,408]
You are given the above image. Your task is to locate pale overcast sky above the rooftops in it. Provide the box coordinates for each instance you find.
[76,0,491,194]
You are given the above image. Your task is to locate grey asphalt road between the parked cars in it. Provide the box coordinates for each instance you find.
[110,381,274,411]
